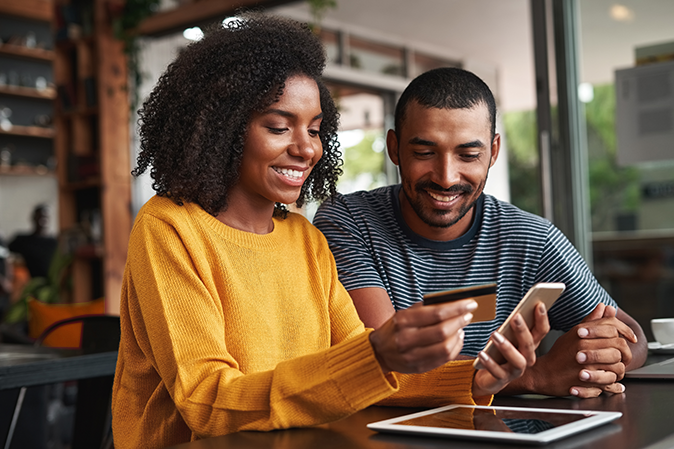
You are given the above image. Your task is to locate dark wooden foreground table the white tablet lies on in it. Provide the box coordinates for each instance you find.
[165,356,674,449]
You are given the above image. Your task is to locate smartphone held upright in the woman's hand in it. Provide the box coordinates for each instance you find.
[473,282,566,369]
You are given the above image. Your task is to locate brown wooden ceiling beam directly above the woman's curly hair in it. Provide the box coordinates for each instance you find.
[136,0,298,36]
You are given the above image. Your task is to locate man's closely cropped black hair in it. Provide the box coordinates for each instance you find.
[395,67,496,140]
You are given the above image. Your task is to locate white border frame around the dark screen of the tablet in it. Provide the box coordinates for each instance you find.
[367,404,622,444]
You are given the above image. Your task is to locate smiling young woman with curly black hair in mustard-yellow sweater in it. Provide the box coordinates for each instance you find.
[112,15,547,448]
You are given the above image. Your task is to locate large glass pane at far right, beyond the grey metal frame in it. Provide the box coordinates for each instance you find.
[579,0,674,339]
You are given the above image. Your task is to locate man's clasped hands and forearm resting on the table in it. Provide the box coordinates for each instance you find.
[512,304,637,398]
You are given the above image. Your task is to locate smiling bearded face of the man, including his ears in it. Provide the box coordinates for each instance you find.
[386,101,500,240]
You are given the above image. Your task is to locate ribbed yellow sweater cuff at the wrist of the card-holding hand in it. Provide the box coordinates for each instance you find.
[328,329,398,410]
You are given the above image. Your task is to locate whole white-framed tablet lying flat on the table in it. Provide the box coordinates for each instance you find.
[367,405,622,444]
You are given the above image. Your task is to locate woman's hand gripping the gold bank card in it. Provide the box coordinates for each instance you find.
[370,300,477,373]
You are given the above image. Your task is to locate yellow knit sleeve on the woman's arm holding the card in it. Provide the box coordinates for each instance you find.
[127,215,397,437]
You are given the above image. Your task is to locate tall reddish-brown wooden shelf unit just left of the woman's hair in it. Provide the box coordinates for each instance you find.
[54,0,131,308]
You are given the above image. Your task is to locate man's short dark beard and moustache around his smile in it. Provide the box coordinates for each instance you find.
[403,179,487,228]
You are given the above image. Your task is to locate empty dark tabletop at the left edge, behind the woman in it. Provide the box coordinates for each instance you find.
[0,344,117,390]
